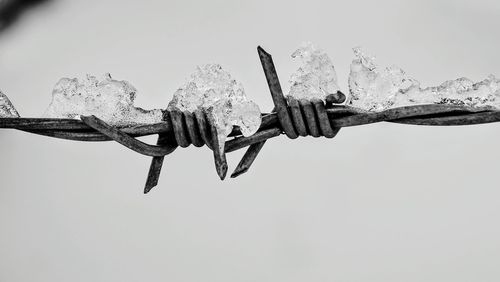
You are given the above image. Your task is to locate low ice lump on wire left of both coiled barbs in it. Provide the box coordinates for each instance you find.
[44,73,163,126]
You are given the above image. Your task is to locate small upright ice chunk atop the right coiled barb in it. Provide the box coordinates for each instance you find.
[288,42,340,100]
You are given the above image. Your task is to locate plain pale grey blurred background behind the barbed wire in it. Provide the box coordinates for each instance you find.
[0,0,500,282]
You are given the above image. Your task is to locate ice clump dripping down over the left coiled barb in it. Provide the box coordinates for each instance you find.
[167,64,261,152]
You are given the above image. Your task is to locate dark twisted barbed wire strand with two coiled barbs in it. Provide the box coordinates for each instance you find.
[0,47,500,193]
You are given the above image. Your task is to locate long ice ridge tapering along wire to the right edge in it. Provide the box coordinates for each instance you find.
[348,47,500,111]
